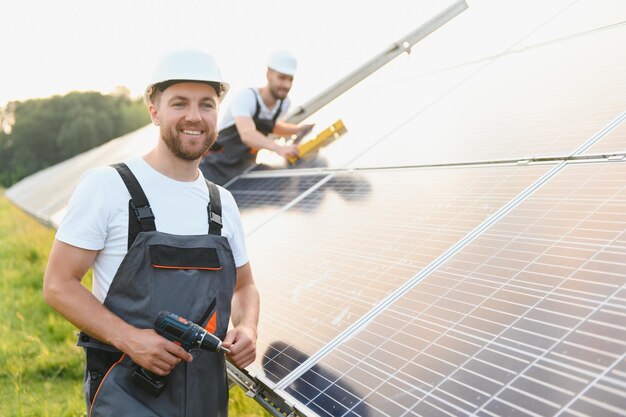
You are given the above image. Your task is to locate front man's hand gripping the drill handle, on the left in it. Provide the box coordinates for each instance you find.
[122,328,193,376]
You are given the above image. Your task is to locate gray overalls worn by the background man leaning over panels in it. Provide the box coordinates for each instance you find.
[200,89,283,185]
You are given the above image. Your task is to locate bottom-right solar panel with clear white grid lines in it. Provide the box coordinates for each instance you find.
[280,162,626,416]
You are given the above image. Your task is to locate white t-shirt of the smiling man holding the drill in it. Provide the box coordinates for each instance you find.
[56,158,248,302]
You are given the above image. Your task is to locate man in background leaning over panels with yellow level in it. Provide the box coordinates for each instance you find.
[200,50,313,185]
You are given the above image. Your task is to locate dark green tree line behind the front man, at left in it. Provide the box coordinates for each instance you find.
[0,90,150,187]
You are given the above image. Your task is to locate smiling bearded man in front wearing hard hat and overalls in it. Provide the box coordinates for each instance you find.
[44,51,259,417]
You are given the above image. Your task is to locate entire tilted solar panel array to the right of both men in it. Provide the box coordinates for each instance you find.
[224,0,626,417]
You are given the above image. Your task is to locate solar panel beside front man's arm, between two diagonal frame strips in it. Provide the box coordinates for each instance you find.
[241,165,552,383]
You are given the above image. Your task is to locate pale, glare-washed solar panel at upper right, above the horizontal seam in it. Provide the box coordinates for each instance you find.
[350,22,626,167]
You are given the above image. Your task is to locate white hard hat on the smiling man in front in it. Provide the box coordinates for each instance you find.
[143,50,230,104]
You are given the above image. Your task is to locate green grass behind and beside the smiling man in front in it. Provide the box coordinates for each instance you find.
[0,189,269,417]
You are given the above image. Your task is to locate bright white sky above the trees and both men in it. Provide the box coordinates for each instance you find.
[0,0,452,110]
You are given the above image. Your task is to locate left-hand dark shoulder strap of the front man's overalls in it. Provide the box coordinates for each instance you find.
[113,163,156,248]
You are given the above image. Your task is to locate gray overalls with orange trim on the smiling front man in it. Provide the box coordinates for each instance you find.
[78,164,236,417]
